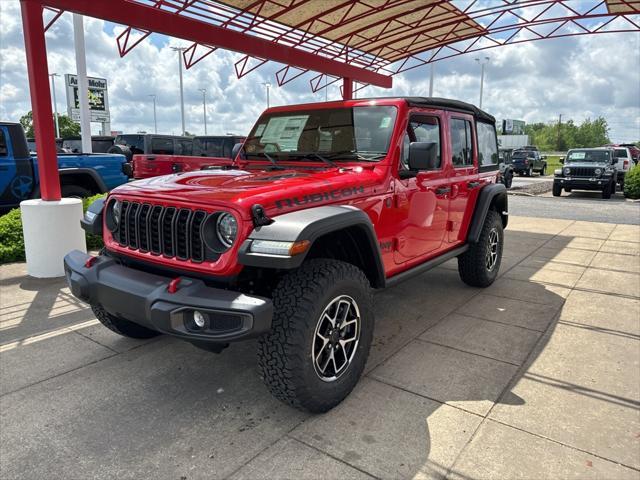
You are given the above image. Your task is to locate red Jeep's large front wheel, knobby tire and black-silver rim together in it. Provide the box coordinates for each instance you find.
[258,259,374,413]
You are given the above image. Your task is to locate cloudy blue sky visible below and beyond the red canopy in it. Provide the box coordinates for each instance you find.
[0,0,640,141]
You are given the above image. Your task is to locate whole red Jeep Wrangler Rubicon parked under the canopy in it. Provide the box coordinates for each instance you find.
[65,98,507,412]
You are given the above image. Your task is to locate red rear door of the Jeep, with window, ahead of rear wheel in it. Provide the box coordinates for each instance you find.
[447,113,480,243]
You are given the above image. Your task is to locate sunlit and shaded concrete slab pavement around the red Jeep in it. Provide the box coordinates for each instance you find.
[0,217,640,480]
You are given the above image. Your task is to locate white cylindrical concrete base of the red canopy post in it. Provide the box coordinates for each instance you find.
[20,198,87,278]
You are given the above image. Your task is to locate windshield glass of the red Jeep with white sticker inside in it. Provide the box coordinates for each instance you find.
[245,106,397,161]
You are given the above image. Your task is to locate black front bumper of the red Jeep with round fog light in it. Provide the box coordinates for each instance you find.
[64,250,273,343]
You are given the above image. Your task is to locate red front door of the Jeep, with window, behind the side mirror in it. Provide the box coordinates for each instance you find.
[394,114,450,264]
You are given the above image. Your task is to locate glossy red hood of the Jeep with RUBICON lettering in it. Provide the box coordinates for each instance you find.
[112,164,387,215]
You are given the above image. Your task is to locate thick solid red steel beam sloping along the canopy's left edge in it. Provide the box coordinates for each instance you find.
[41,0,392,88]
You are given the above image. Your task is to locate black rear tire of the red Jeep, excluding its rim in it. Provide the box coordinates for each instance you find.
[458,210,504,287]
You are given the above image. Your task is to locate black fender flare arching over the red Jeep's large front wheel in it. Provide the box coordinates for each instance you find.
[238,205,385,288]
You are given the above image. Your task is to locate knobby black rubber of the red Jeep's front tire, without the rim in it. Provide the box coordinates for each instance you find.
[258,259,374,413]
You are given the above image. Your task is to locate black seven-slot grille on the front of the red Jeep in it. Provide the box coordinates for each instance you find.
[113,200,208,263]
